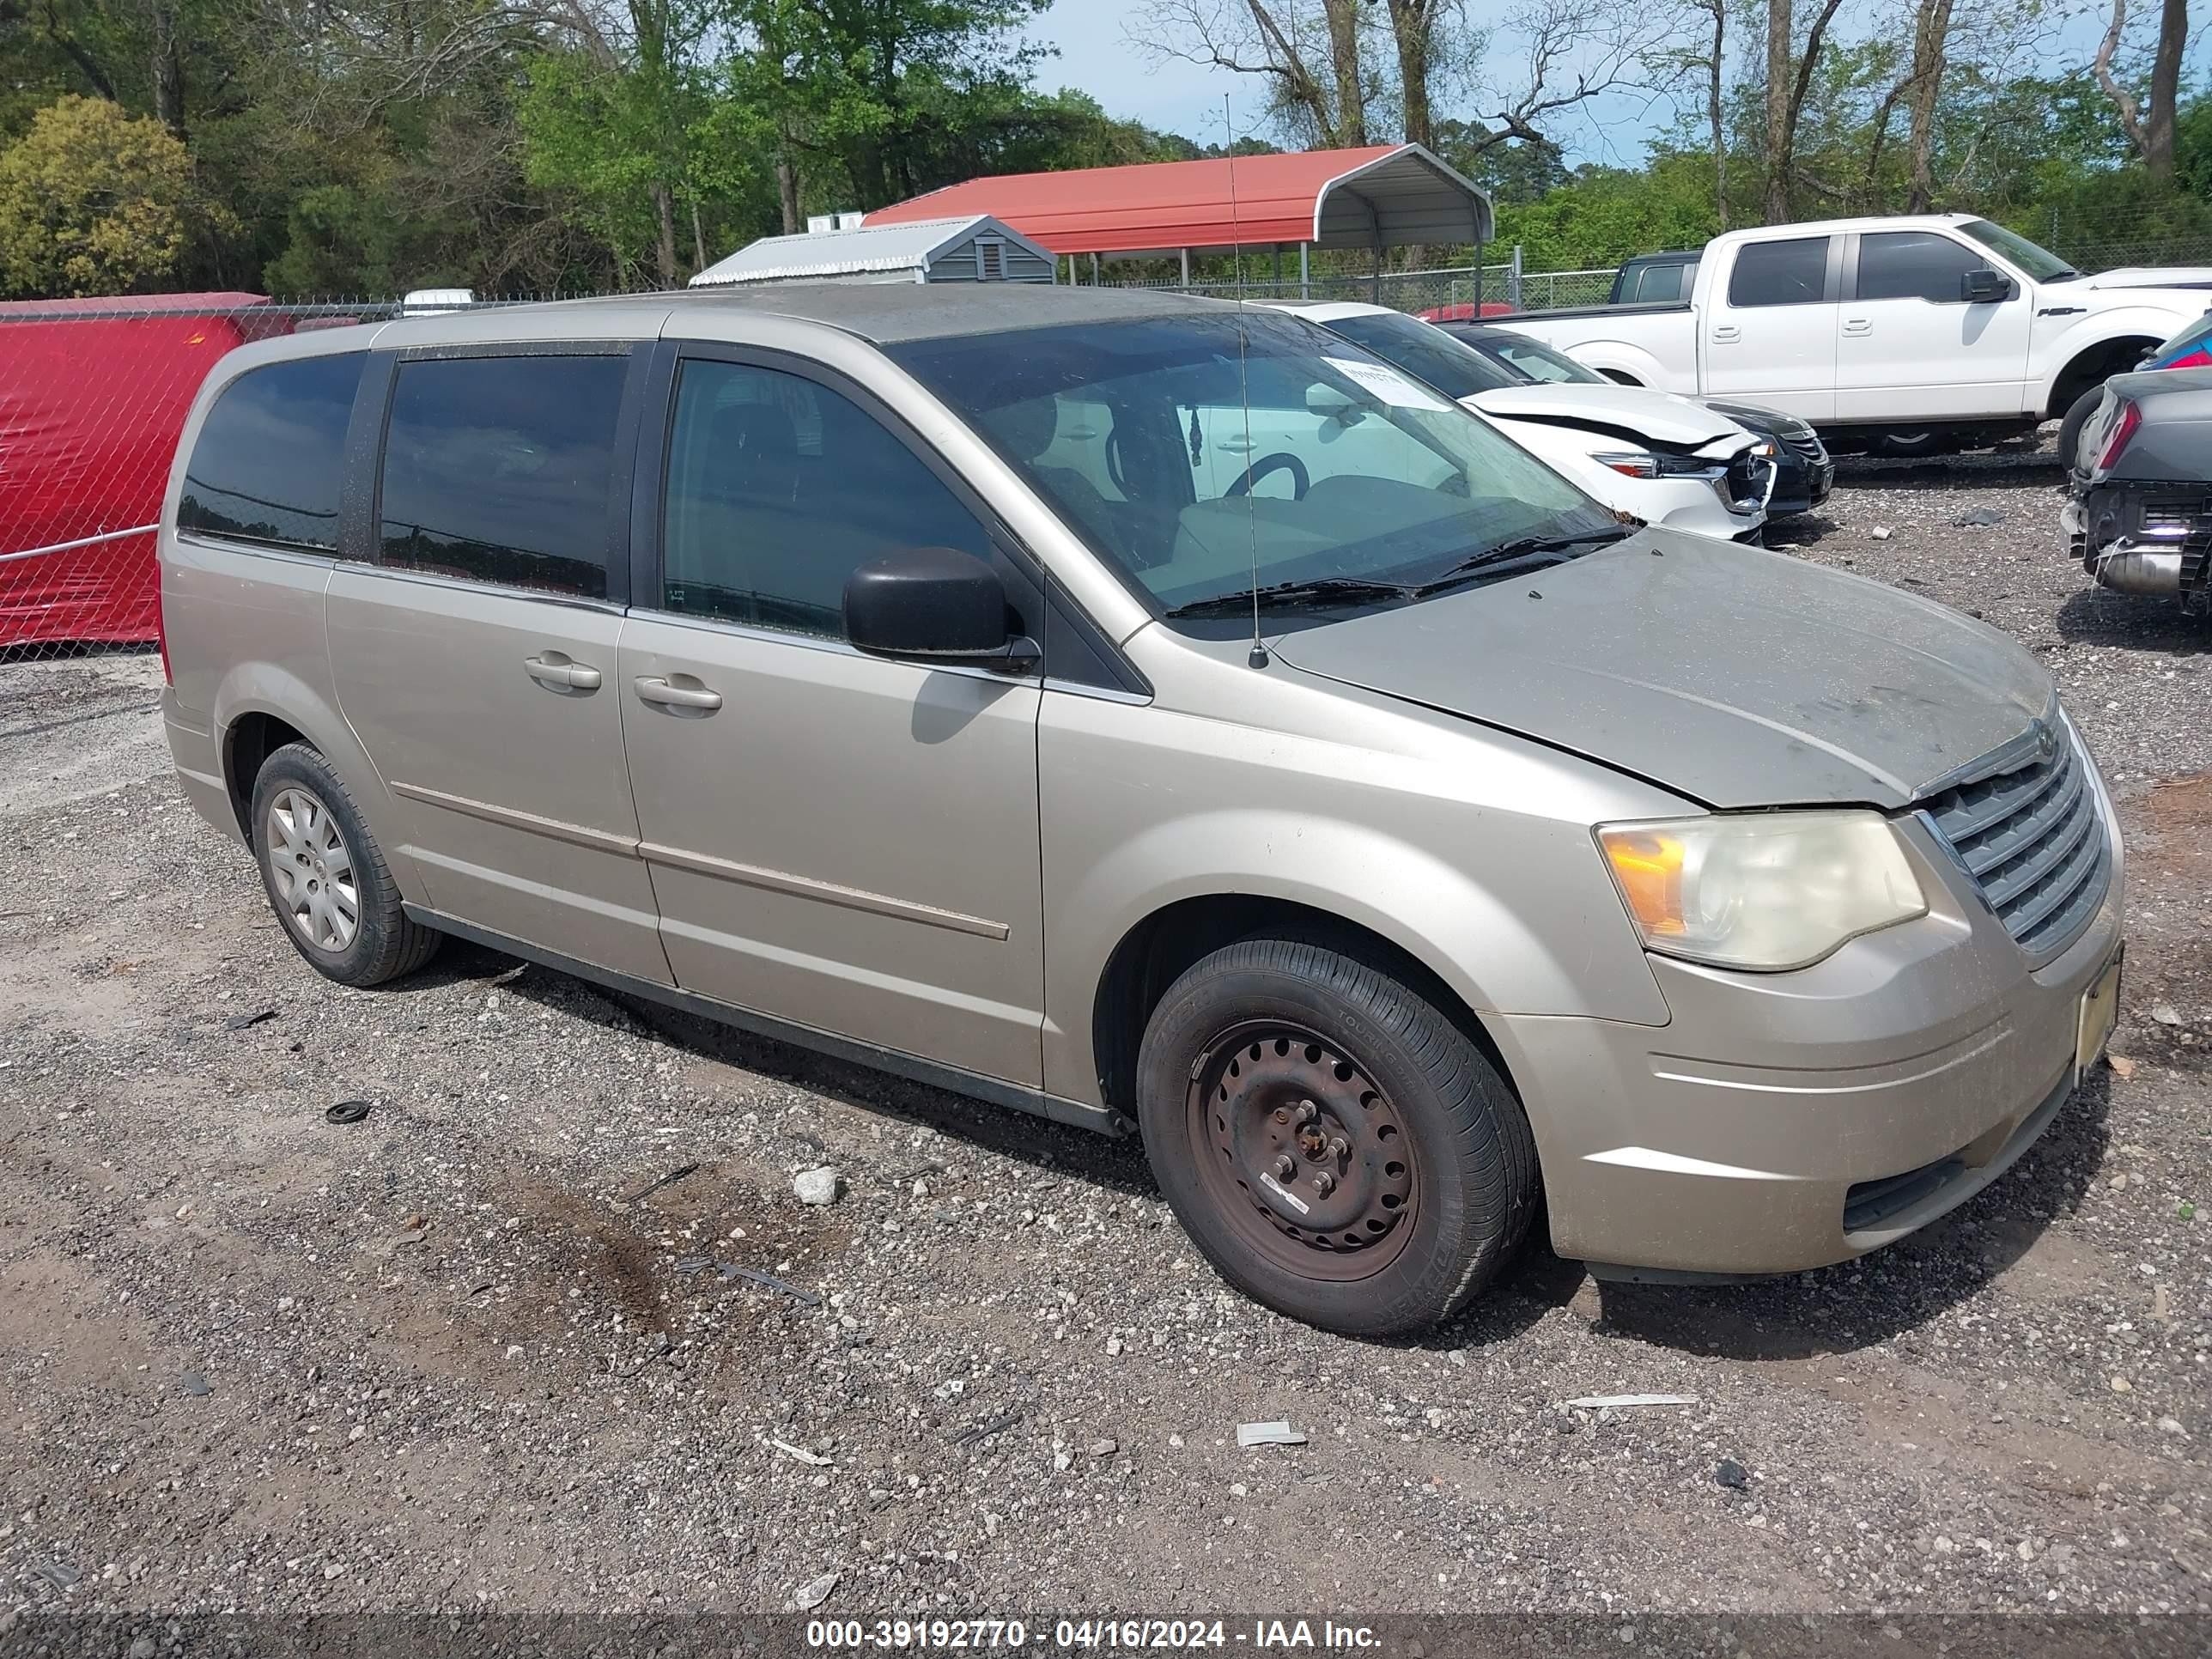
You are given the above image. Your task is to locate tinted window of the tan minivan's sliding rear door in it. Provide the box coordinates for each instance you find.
[378,356,629,599]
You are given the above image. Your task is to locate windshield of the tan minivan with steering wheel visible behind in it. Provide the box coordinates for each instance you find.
[887,307,1621,615]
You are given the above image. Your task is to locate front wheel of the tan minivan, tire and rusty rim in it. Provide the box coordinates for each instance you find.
[1137,938,1537,1336]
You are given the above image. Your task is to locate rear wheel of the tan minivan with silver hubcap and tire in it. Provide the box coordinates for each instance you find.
[250,744,445,987]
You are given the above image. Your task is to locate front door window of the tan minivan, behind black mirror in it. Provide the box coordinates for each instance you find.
[661,358,991,639]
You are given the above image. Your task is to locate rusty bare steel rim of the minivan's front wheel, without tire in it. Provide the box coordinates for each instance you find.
[1186,1020,1418,1281]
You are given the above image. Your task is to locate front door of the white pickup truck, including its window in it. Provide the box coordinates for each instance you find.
[1836,230,2035,420]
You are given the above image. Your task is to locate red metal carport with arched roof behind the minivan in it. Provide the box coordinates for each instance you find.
[867,143,1491,292]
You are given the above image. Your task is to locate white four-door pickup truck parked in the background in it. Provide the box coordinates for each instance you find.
[1486,212,2212,453]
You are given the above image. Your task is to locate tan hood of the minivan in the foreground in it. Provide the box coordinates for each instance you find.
[1276,529,2053,807]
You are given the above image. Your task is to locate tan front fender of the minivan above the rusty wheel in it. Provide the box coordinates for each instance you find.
[1040,699,1668,1119]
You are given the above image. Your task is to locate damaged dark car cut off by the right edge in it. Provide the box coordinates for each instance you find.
[2062,368,2212,615]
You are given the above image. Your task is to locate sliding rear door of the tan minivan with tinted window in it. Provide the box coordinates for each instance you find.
[325,343,668,984]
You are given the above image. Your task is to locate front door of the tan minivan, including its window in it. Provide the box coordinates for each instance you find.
[619,347,1044,1086]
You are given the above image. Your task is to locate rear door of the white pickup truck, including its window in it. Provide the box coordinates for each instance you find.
[1697,237,1840,420]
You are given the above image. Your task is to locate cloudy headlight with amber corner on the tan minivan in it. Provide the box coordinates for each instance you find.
[1597,811,1929,973]
